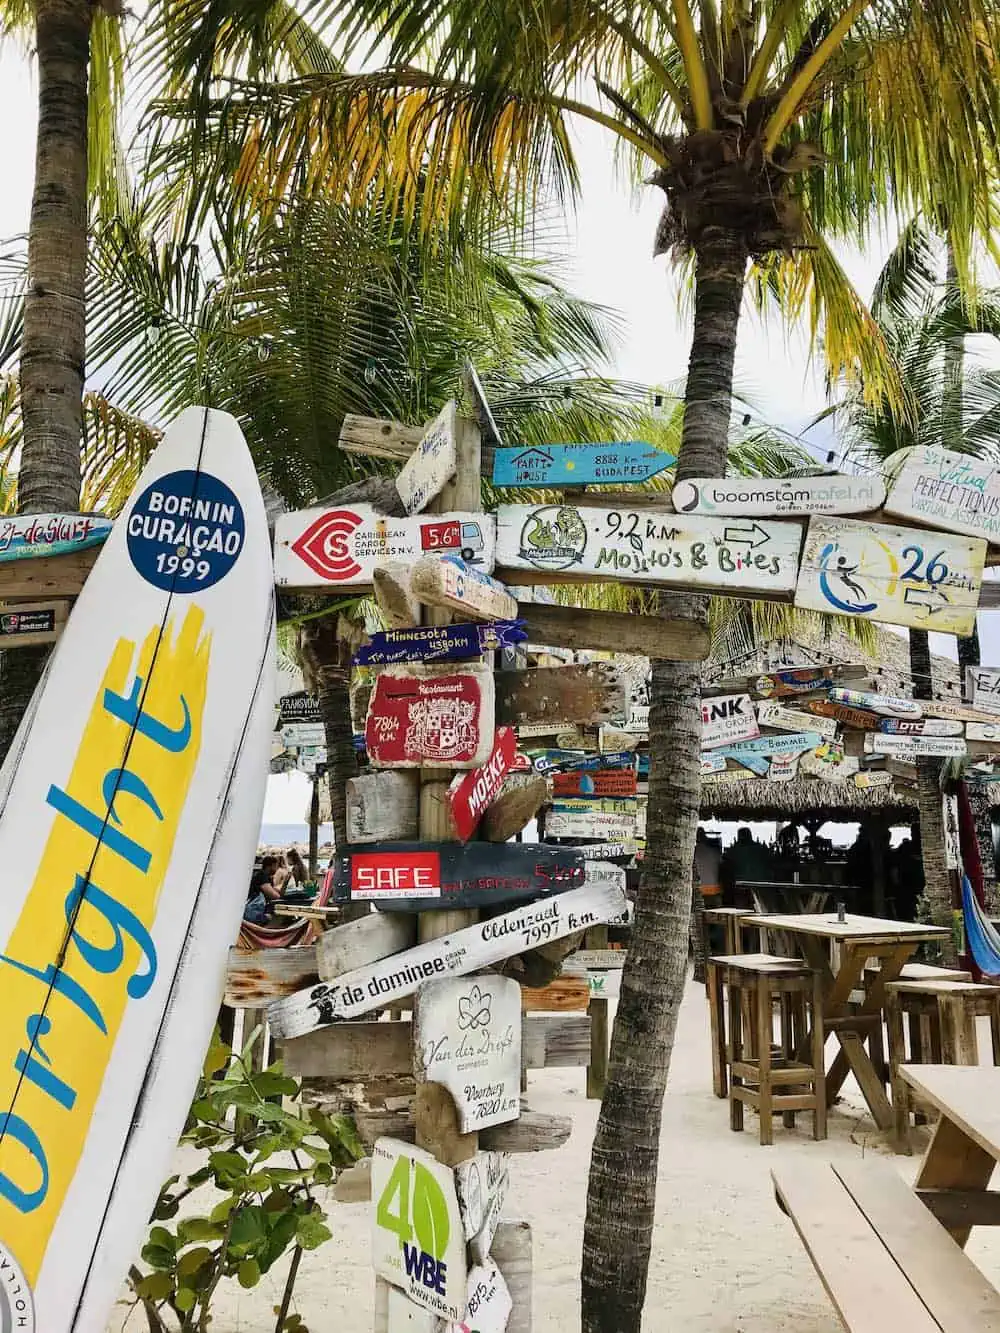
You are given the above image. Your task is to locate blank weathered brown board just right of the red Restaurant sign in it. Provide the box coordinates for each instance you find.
[496,663,625,726]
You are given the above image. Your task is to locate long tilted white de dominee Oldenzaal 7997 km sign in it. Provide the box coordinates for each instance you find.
[268,879,628,1038]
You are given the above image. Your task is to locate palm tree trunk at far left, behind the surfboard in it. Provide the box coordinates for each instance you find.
[0,0,93,756]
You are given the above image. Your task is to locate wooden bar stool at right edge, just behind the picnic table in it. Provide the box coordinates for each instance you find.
[885,980,1000,1153]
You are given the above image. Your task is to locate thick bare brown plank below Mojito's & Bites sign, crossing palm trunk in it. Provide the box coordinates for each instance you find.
[517,601,712,663]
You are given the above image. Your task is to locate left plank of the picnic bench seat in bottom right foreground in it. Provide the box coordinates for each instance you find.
[771,1161,941,1333]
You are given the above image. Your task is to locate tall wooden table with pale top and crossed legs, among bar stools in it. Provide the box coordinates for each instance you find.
[743,912,948,1130]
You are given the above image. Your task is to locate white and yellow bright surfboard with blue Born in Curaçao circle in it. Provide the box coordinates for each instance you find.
[0,408,275,1333]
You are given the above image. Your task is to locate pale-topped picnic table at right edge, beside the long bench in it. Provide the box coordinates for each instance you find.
[900,1065,1000,1246]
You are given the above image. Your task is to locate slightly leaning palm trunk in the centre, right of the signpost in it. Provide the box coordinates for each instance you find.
[581,232,747,1333]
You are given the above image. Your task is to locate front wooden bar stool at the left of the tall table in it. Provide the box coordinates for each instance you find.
[709,953,827,1144]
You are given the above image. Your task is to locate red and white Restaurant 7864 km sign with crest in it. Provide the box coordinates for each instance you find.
[364,664,493,768]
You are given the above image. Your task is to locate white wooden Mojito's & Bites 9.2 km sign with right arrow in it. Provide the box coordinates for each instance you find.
[497,505,801,597]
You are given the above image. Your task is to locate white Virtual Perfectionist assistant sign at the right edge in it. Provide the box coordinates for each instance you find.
[885,445,1000,541]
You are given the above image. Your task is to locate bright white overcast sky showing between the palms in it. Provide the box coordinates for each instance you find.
[0,43,1000,824]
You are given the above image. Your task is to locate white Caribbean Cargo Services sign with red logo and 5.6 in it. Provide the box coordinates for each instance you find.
[275,504,496,588]
